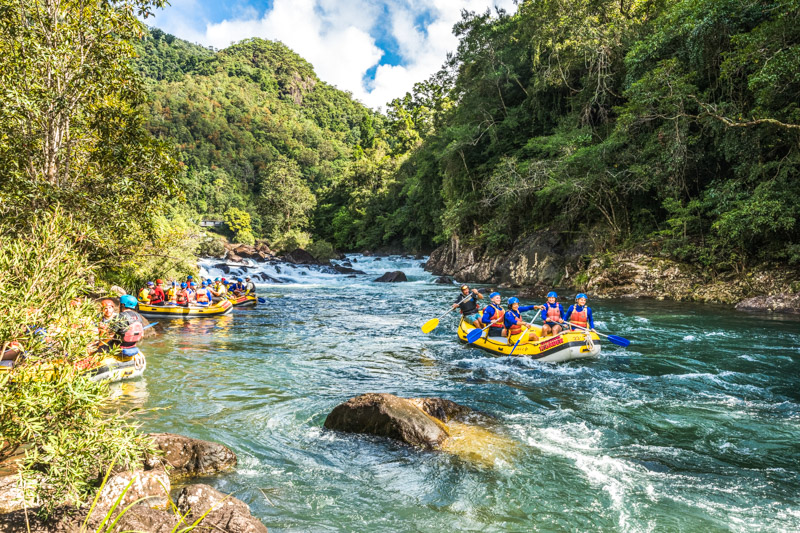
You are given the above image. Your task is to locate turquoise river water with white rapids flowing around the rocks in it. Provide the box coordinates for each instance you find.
[123,257,800,532]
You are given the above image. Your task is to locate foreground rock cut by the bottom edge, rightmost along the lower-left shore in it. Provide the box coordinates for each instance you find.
[176,484,267,533]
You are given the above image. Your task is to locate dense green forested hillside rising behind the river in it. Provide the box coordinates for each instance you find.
[140,0,800,270]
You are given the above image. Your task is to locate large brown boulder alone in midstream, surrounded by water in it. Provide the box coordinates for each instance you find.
[324,393,448,449]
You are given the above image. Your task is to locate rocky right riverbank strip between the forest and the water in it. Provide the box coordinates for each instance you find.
[426,232,800,312]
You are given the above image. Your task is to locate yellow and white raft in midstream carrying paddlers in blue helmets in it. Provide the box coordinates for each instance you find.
[458,318,601,363]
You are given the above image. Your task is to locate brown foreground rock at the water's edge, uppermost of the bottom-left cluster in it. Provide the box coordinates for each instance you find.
[146,433,236,476]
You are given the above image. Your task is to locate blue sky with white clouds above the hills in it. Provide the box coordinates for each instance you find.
[146,0,516,108]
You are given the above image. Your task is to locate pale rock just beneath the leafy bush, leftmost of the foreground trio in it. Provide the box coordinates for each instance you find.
[96,469,170,514]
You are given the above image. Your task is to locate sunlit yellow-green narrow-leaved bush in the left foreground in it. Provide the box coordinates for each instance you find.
[0,212,150,512]
